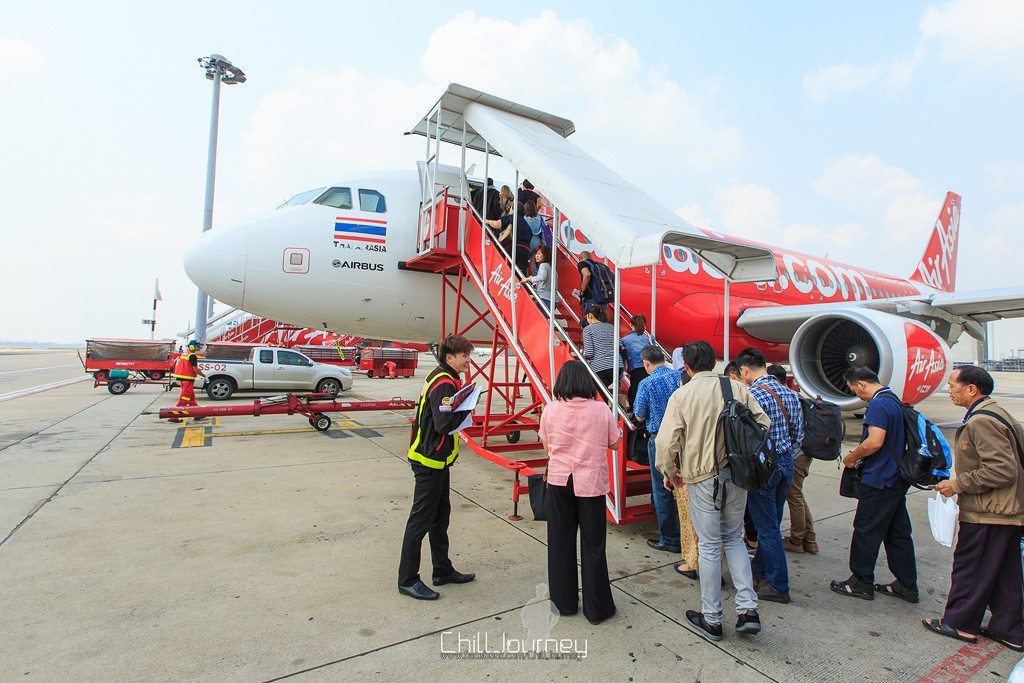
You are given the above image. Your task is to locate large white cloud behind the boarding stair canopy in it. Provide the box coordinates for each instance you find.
[246,11,742,202]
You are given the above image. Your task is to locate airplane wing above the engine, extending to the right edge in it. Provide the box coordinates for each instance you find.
[736,288,1024,343]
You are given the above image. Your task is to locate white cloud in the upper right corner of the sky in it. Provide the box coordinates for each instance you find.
[804,0,1024,104]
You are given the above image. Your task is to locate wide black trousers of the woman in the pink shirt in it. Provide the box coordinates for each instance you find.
[548,475,615,621]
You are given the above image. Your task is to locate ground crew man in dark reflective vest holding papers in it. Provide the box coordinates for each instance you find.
[398,335,476,600]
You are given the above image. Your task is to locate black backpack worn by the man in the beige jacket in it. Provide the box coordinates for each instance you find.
[715,377,778,490]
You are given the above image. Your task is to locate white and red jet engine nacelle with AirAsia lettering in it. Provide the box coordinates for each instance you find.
[790,309,949,411]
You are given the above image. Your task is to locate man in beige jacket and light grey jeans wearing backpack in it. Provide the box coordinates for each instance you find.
[655,341,771,640]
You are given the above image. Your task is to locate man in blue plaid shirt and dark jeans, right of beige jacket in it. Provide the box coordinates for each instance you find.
[736,348,804,603]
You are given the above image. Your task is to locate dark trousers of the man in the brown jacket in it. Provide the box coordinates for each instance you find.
[942,522,1024,645]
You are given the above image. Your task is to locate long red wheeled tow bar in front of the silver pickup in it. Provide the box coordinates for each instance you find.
[159,393,416,432]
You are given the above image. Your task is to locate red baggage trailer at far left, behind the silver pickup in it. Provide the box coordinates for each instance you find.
[78,339,178,395]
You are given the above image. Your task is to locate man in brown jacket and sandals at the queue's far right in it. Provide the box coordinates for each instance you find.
[925,366,1024,651]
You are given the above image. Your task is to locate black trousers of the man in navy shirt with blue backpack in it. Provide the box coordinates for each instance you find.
[850,481,918,590]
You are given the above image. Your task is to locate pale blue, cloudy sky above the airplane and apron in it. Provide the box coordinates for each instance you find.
[0,1,1024,352]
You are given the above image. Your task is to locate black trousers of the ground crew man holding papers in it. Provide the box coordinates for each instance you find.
[398,463,455,586]
